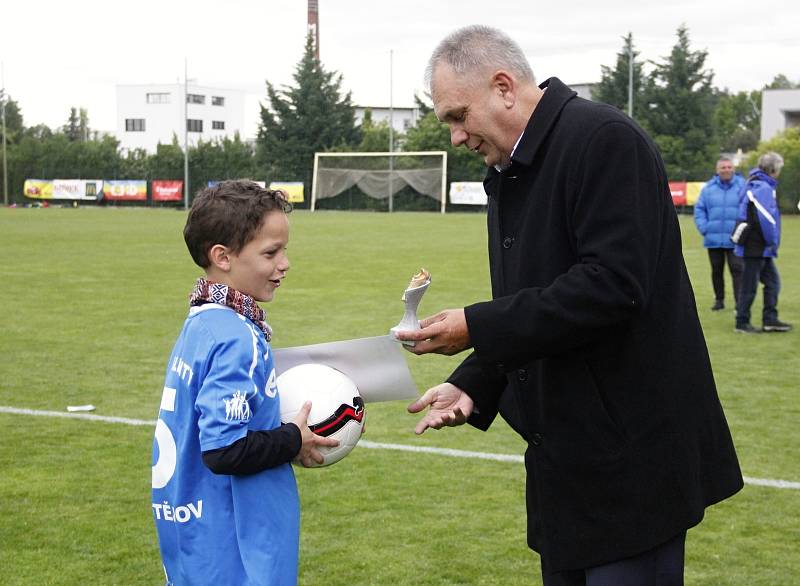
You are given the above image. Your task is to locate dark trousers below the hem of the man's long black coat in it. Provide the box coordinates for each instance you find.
[542,532,686,586]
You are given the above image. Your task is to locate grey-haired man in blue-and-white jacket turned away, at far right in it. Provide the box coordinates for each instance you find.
[732,152,792,334]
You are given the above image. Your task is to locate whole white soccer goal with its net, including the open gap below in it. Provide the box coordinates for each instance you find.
[311,151,447,213]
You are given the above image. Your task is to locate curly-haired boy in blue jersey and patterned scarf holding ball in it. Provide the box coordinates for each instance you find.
[152,181,338,585]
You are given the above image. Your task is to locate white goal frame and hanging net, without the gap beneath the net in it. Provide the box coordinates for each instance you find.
[311,151,447,213]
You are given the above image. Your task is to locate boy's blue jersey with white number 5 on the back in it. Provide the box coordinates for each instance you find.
[153,304,300,585]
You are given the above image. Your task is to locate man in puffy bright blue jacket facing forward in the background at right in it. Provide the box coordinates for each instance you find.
[694,157,744,311]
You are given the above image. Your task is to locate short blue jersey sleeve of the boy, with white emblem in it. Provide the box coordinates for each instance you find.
[195,324,263,452]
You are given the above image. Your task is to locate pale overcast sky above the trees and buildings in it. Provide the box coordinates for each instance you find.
[0,0,800,135]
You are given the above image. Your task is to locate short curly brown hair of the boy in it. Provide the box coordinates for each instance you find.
[183,180,292,269]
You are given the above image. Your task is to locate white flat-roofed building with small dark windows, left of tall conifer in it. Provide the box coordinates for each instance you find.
[117,83,246,153]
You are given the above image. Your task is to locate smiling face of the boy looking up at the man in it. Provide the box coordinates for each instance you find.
[227,211,289,301]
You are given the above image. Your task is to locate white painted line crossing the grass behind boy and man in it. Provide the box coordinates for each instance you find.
[0,405,800,490]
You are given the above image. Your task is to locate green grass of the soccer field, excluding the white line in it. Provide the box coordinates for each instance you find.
[0,209,800,586]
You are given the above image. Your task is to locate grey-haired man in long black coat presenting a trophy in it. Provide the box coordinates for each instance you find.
[398,26,742,585]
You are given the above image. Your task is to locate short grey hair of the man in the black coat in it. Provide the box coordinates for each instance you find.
[425,24,536,92]
